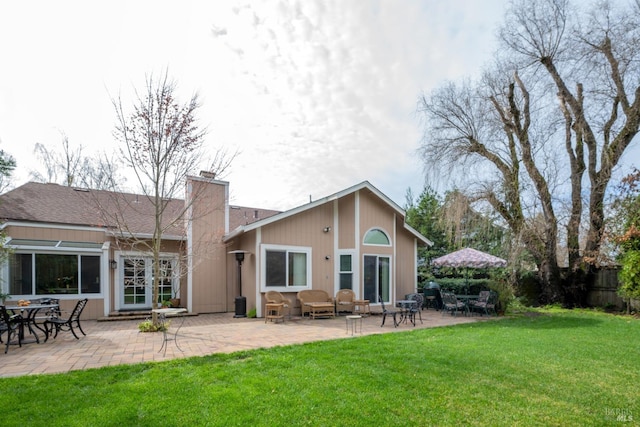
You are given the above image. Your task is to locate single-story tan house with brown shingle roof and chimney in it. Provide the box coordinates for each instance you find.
[0,174,431,319]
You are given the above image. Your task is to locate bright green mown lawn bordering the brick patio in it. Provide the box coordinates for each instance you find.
[0,310,640,427]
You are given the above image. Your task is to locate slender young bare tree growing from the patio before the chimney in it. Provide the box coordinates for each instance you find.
[113,72,233,323]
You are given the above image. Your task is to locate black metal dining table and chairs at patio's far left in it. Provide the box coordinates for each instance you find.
[0,298,88,354]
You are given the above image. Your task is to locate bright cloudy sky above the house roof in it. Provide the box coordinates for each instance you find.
[0,0,507,209]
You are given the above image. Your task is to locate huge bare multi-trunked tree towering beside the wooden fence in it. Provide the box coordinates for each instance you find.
[420,0,640,304]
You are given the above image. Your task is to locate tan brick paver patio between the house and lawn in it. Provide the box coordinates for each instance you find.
[0,310,487,377]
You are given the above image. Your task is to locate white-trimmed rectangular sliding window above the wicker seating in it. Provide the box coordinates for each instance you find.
[262,245,311,292]
